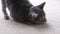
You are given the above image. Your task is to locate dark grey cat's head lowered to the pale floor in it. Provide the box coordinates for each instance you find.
[29,2,46,23]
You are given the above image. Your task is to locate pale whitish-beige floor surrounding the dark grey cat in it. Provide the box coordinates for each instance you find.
[0,0,60,34]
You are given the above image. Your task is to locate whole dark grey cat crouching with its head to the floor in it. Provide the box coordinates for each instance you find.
[2,0,46,24]
